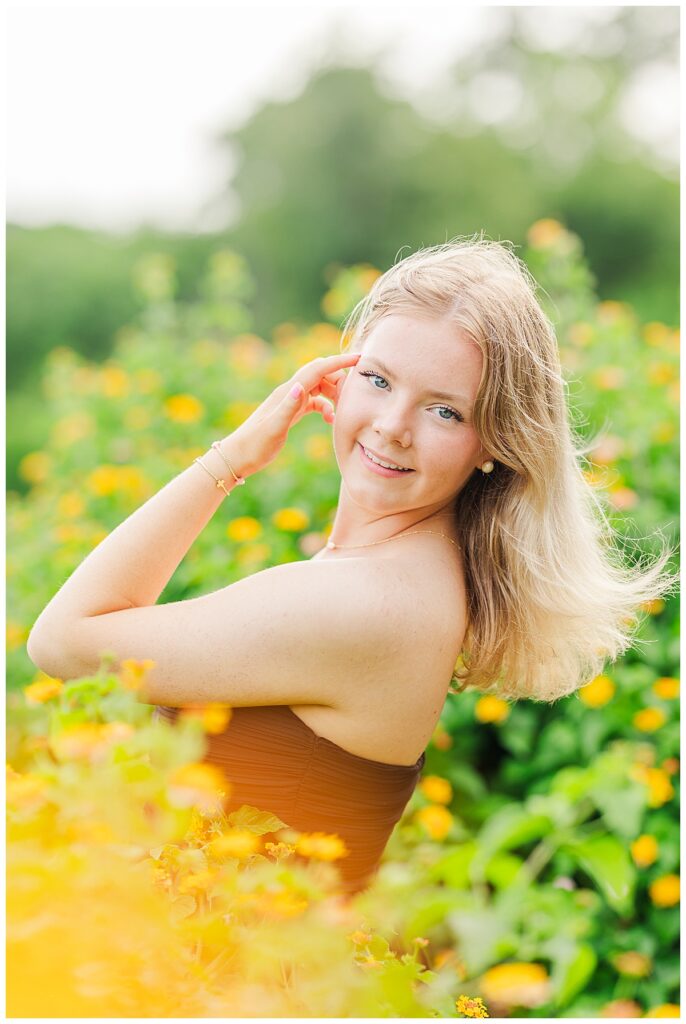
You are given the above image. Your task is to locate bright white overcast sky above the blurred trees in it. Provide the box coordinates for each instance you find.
[6,0,678,231]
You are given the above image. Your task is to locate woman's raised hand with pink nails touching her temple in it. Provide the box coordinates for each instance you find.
[222,352,361,476]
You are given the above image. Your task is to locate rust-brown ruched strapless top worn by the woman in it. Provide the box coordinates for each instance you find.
[154,705,425,894]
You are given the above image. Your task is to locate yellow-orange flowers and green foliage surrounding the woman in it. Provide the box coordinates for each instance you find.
[7,220,680,1017]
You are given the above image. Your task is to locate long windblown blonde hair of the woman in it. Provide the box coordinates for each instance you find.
[341,236,677,701]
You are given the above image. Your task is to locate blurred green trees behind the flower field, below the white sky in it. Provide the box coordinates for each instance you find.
[7,7,679,493]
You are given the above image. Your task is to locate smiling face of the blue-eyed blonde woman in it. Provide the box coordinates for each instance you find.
[334,314,488,514]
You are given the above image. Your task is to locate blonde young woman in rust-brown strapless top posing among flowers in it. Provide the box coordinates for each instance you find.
[29,239,673,892]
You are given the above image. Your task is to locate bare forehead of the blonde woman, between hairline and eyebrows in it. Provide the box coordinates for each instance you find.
[360,313,483,389]
